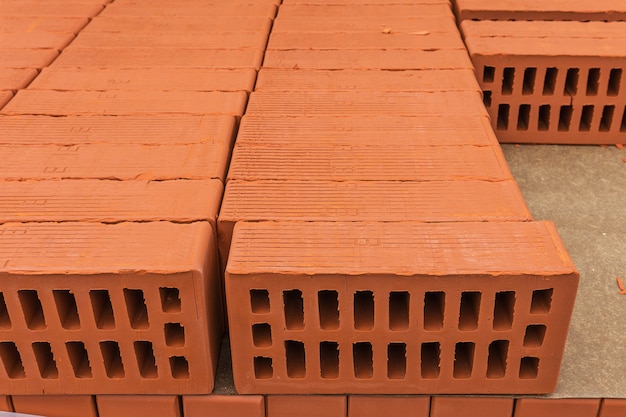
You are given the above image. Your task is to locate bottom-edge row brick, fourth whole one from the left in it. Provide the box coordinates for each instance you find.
[266,395,348,417]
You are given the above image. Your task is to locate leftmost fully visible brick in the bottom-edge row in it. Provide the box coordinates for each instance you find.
[12,395,98,417]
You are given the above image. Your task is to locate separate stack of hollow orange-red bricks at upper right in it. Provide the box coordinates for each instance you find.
[456,0,626,144]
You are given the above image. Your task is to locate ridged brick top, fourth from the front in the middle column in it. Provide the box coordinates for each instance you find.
[236,112,498,146]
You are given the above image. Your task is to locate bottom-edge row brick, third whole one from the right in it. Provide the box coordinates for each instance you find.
[348,395,430,417]
